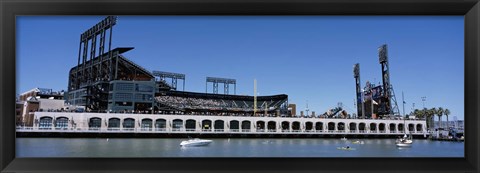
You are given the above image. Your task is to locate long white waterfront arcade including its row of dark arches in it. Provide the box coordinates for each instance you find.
[17,112,428,137]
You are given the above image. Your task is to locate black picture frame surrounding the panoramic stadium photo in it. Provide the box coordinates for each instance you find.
[0,0,480,173]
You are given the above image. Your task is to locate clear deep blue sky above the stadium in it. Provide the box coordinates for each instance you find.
[16,16,464,120]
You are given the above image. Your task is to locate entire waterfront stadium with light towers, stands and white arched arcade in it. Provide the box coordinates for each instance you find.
[17,16,427,137]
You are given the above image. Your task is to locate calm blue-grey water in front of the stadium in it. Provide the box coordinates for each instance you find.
[16,138,464,157]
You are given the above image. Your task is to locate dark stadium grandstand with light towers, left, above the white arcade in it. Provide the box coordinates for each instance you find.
[66,16,288,116]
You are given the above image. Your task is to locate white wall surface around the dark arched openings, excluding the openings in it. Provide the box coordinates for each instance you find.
[34,112,426,133]
